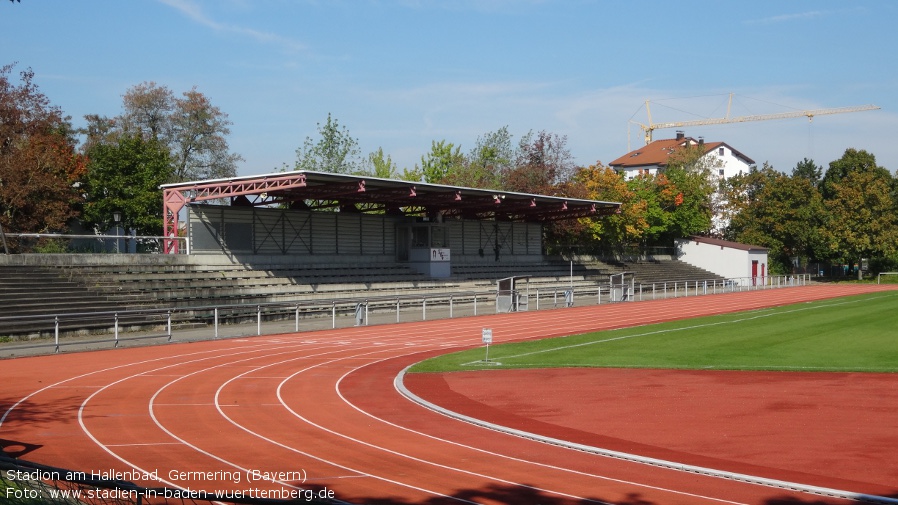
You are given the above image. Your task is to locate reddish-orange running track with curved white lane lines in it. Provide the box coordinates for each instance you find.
[0,285,898,505]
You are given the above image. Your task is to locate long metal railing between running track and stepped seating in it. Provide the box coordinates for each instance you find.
[0,275,810,356]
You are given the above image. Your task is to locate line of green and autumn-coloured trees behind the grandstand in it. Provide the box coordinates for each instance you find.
[0,64,898,273]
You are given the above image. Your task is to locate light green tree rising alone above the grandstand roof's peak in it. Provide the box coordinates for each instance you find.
[296,113,364,174]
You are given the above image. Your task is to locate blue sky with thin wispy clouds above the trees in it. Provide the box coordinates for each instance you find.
[0,0,898,175]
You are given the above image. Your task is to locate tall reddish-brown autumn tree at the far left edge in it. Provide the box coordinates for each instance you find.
[0,65,84,232]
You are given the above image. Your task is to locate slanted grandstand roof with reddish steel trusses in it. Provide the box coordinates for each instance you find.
[161,171,620,221]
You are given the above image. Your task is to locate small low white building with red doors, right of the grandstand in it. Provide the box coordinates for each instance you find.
[676,237,768,286]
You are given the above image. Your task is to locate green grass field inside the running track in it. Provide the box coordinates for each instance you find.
[410,292,898,372]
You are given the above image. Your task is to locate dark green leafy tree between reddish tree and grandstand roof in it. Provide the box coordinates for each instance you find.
[84,134,173,236]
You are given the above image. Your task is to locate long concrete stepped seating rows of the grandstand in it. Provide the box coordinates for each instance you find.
[0,255,718,335]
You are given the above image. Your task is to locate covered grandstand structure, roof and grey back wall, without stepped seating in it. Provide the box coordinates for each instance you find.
[162,171,620,278]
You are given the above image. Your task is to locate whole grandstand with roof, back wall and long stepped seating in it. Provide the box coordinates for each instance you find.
[0,172,719,335]
